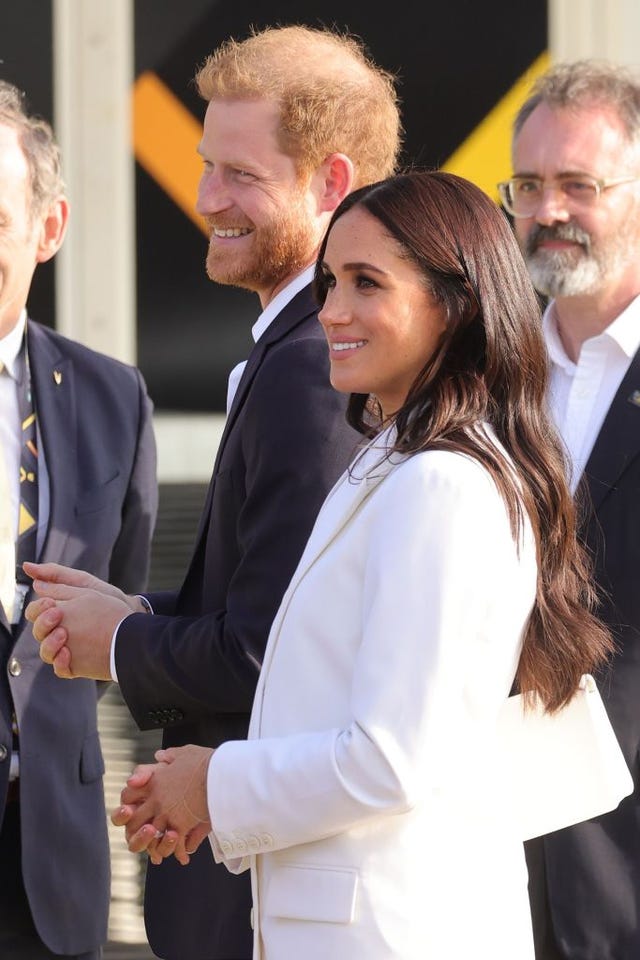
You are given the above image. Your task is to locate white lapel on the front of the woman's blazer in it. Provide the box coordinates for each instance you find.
[249,432,406,738]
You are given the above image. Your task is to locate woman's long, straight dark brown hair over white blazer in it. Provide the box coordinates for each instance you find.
[315,171,613,711]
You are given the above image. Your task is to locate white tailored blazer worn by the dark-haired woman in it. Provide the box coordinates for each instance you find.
[208,434,536,960]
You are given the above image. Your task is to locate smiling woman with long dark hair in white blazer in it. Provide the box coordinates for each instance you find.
[119,172,611,960]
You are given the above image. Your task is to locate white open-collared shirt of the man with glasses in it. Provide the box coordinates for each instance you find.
[542,296,640,492]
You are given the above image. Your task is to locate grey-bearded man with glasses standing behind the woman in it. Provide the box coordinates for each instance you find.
[499,60,640,960]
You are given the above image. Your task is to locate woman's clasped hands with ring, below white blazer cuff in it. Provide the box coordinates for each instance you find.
[111,744,213,864]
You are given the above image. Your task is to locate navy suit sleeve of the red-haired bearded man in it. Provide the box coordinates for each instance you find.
[115,338,357,729]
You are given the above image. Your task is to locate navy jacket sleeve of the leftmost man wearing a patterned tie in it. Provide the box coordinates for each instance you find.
[109,370,158,593]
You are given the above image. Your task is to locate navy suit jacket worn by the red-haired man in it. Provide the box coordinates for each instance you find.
[116,287,360,960]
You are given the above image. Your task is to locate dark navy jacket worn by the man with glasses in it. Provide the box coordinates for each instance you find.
[531,351,640,960]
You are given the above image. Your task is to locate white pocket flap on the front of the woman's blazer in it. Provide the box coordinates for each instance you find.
[264,864,358,923]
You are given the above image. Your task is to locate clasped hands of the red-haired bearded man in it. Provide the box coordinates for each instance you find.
[24,563,142,680]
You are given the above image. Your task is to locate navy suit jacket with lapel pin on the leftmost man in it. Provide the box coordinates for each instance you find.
[0,320,157,954]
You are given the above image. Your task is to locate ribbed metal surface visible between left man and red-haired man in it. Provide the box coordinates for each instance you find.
[98,484,207,940]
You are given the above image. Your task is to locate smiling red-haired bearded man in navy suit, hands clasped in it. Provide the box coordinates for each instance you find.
[29,27,400,960]
